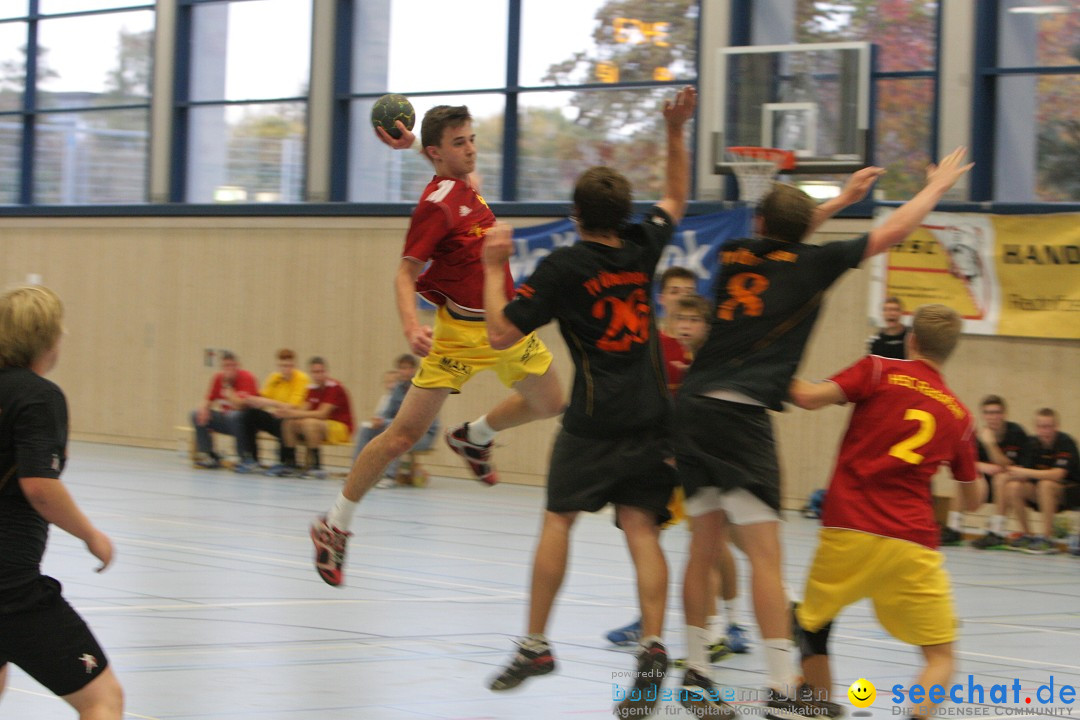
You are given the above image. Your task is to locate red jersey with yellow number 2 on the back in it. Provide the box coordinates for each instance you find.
[821,355,976,548]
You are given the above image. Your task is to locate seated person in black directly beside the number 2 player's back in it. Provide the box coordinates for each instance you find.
[942,395,1027,549]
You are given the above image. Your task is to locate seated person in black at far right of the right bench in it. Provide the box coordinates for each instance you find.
[1004,408,1080,555]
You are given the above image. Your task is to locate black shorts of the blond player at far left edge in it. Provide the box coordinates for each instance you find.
[0,576,109,695]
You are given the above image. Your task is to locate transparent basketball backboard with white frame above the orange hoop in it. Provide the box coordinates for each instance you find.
[713,42,873,174]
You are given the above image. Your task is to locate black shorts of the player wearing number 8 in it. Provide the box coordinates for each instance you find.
[675,395,780,512]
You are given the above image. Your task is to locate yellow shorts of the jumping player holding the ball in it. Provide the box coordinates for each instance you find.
[413,307,551,393]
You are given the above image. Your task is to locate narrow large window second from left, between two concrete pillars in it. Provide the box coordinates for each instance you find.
[183,0,311,203]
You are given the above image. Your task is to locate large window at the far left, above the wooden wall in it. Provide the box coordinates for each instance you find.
[0,0,154,204]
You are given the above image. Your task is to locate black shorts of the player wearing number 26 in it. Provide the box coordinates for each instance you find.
[548,429,678,525]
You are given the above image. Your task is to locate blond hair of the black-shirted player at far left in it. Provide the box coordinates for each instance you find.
[0,285,64,367]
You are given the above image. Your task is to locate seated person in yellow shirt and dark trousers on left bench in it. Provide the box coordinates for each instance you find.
[233,350,311,473]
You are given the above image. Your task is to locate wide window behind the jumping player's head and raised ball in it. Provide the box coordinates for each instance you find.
[347,0,698,202]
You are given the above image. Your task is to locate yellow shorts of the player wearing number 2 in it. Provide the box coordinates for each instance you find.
[796,528,956,646]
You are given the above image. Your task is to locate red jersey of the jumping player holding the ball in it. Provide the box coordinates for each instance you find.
[402,175,514,312]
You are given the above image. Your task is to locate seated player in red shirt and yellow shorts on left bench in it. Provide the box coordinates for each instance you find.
[267,357,352,477]
